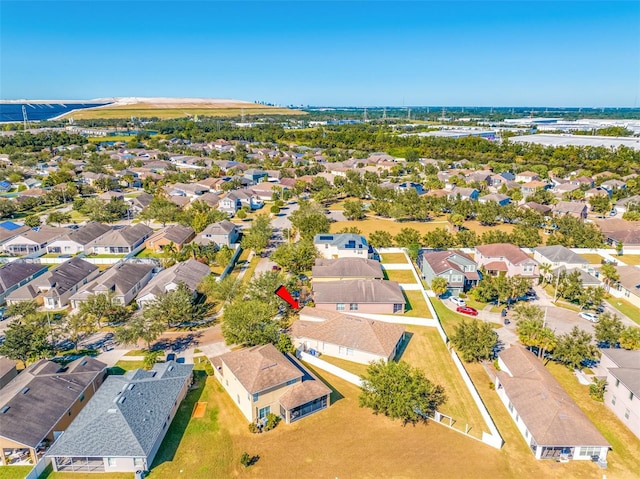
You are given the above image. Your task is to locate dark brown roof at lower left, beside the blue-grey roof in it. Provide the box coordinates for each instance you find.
[0,357,106,447]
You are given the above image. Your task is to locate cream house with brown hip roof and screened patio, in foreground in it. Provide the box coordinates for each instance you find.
[211,344,331,425]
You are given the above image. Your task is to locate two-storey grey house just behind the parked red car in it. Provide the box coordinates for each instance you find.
[417,251,480,296]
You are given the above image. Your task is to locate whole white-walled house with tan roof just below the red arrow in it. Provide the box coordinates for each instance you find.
[289,307,405,364]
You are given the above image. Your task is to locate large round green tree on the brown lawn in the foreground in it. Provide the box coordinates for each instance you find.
[359,360,447,425]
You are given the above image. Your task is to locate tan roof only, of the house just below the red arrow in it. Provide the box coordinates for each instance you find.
[291,307,404,358]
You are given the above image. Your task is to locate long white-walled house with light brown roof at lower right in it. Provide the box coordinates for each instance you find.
[495,346,611,464]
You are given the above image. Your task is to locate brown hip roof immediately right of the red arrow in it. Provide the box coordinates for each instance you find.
[313,279,406,304]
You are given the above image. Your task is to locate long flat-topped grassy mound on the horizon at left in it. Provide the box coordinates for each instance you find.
[64,103,305,121]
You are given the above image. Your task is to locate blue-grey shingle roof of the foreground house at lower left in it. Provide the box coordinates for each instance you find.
[47,361,193,457]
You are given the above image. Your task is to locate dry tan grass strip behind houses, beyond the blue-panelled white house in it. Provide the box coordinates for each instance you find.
[330,217,513,238]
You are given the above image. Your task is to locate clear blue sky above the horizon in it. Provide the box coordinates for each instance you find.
[0,0,640,107]
